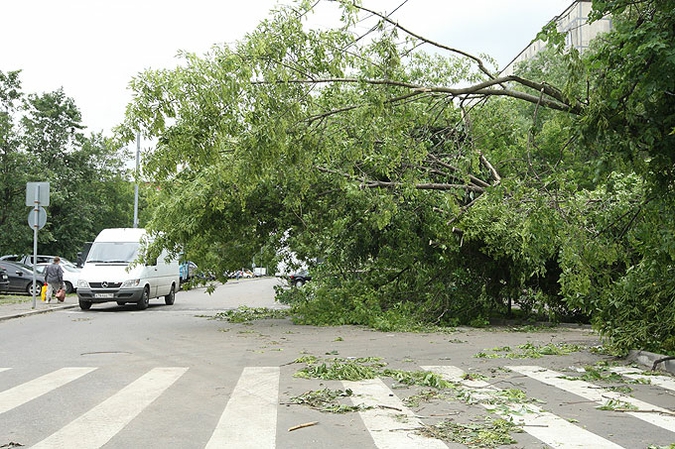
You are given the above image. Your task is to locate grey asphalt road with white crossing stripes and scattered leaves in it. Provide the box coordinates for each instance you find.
[0,278,675,449]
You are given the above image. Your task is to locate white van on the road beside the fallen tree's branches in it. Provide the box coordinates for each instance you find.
[77,228,180,310]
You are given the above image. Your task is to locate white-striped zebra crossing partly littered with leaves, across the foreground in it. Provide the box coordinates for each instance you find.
[0,365,675,449]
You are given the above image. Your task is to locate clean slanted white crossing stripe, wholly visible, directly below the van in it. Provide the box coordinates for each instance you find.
[32,368,188,449]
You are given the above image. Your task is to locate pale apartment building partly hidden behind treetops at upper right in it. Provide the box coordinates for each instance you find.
[501,0,612,75]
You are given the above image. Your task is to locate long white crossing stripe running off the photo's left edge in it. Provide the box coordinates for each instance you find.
[0,367,96,414]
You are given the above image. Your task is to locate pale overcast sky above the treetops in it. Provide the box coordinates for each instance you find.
[0,0,572,135]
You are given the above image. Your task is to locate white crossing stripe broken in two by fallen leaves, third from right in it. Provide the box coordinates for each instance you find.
[422,366,622,449]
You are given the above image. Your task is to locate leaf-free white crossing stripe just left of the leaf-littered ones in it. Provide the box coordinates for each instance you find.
[206,367,280,449]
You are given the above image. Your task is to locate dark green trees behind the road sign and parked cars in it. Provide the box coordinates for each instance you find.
[0,71,133,261]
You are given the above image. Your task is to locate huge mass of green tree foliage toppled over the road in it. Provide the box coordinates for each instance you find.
[119,0,675,351]
